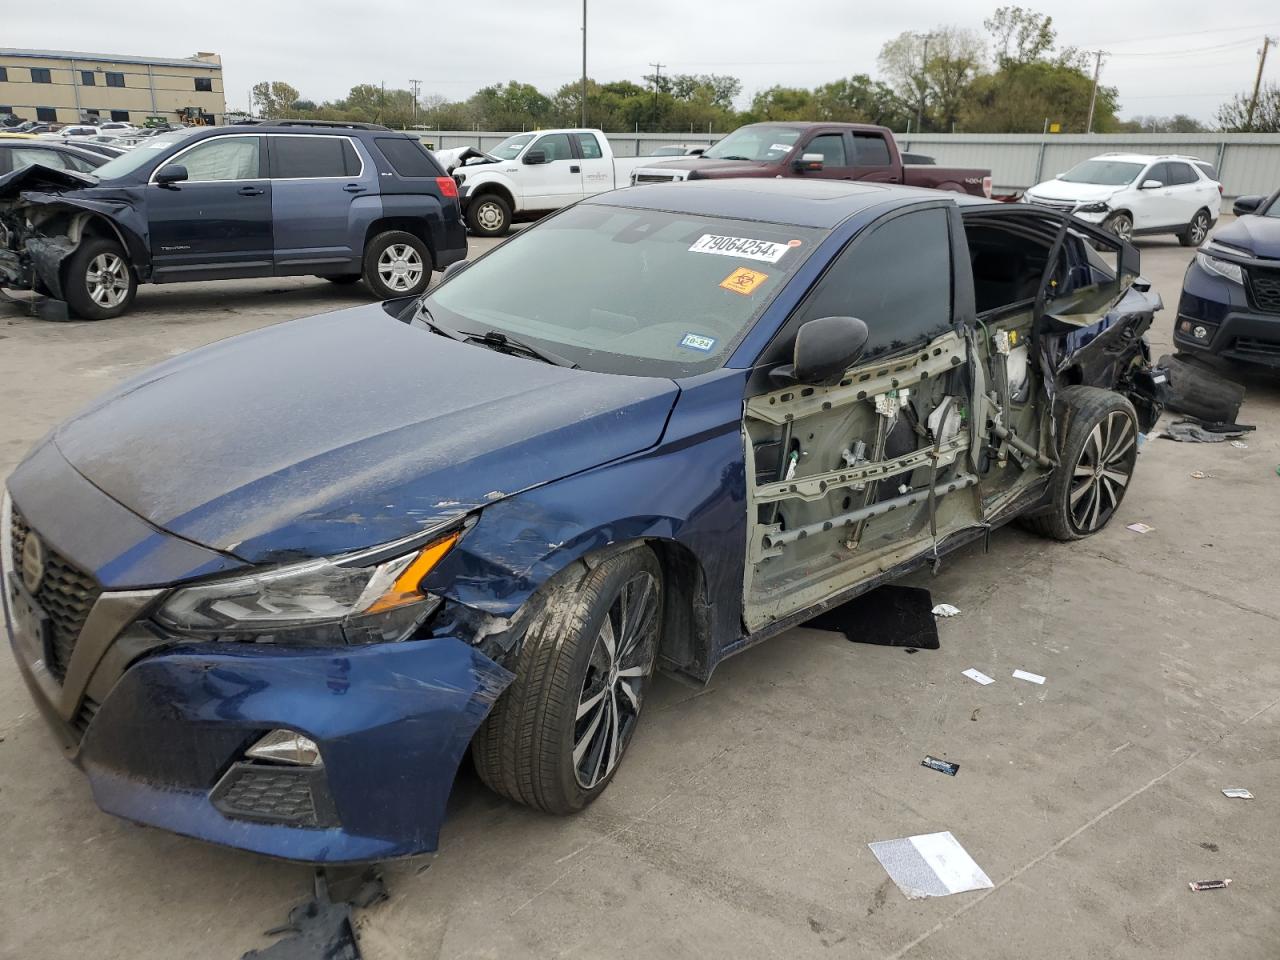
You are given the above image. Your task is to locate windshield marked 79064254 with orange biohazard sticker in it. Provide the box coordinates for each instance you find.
[420,204,824,376]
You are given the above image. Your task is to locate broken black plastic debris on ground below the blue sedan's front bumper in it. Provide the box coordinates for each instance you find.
[241,868,387,960]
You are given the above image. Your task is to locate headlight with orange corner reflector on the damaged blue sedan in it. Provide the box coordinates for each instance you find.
[155,529,463,646]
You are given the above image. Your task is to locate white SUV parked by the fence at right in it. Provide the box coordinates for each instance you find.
[1023,154,1222,247]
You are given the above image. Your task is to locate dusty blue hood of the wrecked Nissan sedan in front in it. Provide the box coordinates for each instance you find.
[54,305,680,563]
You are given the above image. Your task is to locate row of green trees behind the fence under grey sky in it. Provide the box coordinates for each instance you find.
[252,6,1280,133]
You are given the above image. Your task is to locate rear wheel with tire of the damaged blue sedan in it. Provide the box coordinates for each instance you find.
[1024,387,1138,540]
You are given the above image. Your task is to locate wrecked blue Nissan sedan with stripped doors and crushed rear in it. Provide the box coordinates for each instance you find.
[0,179,1160,861]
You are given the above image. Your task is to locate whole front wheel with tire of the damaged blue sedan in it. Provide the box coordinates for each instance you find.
[471,547,663,815]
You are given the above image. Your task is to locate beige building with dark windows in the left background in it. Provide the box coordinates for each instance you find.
[0,47,227,127]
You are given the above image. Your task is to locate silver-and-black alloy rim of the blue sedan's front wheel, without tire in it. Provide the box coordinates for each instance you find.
[573,573,658,790]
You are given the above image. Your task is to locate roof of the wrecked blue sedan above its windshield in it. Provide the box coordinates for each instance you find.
[585,178,993,229]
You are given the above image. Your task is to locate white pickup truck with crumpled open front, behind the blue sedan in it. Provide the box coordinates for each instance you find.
[435,129,660,237]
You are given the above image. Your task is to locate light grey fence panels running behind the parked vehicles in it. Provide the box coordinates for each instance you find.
[416,131,1280,197]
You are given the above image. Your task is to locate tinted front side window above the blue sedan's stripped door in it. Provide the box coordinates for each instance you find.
[792,209,951,358]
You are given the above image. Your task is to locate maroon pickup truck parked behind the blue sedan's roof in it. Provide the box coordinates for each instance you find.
[631,123,991,197]
